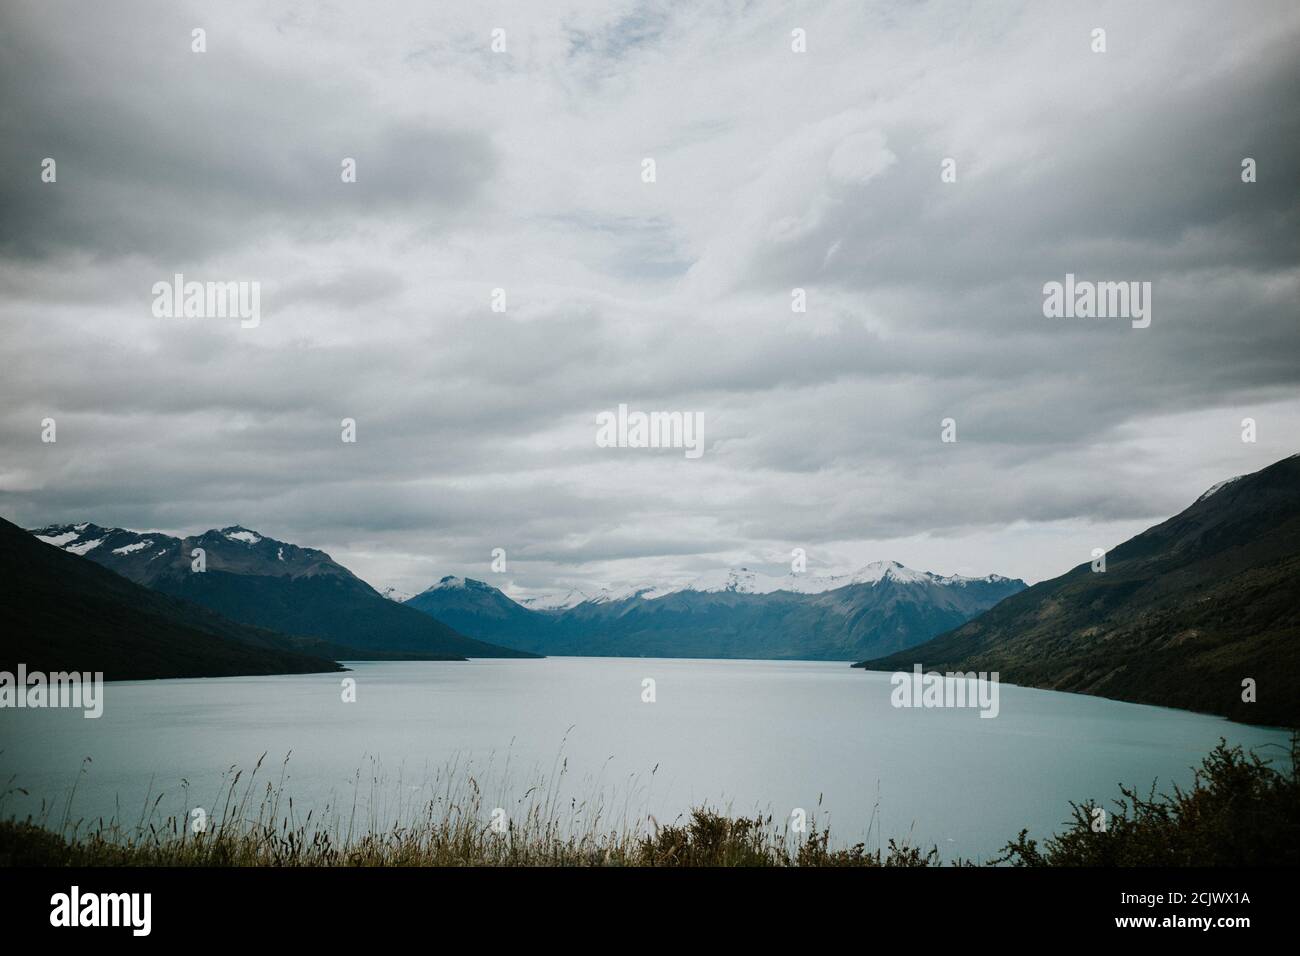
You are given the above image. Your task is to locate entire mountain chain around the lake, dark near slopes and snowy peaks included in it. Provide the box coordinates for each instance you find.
[15,455,1300,726]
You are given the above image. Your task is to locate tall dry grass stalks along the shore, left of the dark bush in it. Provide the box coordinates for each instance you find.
[0,754,937,866]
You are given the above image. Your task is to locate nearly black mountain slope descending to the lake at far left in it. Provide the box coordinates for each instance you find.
[0,519,343,680]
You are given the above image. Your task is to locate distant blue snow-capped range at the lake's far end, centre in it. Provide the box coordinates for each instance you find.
[406,562,1024,661]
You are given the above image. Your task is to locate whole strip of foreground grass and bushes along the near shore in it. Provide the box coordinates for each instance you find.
[0,736,1300,866]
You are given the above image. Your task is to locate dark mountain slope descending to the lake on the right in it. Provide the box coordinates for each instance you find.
[855,455,1300,726]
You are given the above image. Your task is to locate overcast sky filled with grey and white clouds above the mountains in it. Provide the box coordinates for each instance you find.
[0,0,1300,596]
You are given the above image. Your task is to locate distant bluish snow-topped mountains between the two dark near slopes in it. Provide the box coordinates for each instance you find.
[22,522,1024,661]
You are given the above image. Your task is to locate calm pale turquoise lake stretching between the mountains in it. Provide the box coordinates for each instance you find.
[0,658,1288,860]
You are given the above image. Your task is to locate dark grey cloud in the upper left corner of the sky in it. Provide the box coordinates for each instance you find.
[0,4,495,263]
